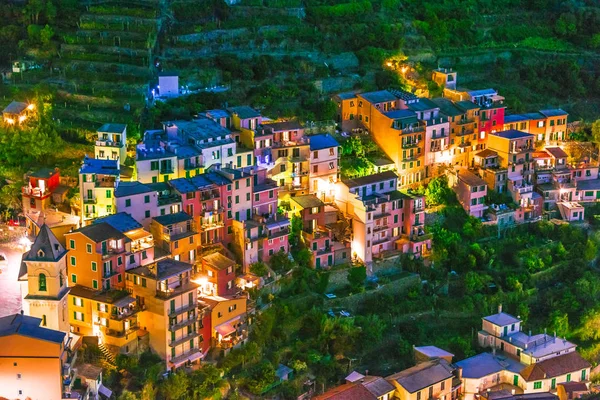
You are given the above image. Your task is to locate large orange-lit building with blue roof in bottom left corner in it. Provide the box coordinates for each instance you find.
[0,314,73,400]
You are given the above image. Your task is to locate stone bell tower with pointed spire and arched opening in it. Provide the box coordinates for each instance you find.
[19,225,70,332]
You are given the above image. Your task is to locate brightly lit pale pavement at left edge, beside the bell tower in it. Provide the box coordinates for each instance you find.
[0,244,23,317]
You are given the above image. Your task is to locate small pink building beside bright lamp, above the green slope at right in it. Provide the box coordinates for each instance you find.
[448,168,487,218]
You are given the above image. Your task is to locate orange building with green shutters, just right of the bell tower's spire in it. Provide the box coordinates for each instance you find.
[65,222,131,290]
